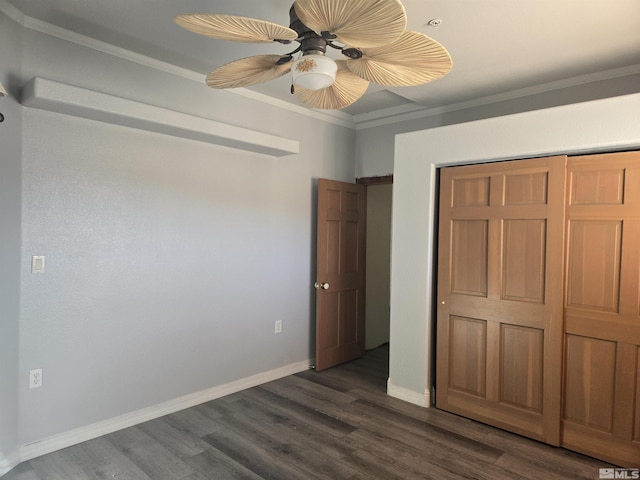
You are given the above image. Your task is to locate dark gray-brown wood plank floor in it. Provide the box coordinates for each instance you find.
[2,347,608,480]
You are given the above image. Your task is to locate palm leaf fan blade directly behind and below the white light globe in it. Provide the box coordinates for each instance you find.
[295,60,369,110]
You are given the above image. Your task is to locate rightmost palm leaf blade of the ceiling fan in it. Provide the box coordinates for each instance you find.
[347,30,453,87]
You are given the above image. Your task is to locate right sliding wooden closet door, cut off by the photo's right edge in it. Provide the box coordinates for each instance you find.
[562,152,640,468]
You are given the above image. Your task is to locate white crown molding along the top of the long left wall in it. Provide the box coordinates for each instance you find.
[0,0,355,128]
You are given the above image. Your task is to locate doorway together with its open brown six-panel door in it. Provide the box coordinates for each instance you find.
[315,175,393,370]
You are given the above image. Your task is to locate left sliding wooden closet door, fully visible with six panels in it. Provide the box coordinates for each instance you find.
[436,157,566,445]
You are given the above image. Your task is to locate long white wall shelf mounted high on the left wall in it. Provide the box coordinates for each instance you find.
[22,77,300,157]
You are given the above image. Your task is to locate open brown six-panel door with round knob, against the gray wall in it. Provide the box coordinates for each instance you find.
[316,179,366,370]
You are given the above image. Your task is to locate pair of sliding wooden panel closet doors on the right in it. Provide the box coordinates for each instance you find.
[436,152,640,467]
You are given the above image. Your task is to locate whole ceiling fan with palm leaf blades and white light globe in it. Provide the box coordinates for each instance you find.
[175,0,452,110]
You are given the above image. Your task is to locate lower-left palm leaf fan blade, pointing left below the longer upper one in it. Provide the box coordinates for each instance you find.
[207,55,291,88]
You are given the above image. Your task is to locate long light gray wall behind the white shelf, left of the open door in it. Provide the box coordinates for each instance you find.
[0,12,355,458]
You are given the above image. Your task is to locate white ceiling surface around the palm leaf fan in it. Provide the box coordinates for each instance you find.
[8,0,640,116]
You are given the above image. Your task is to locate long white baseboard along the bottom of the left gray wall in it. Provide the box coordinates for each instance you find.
[12,360,312,468]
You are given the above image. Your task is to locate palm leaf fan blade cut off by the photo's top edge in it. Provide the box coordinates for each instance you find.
[294,0,407,48]
